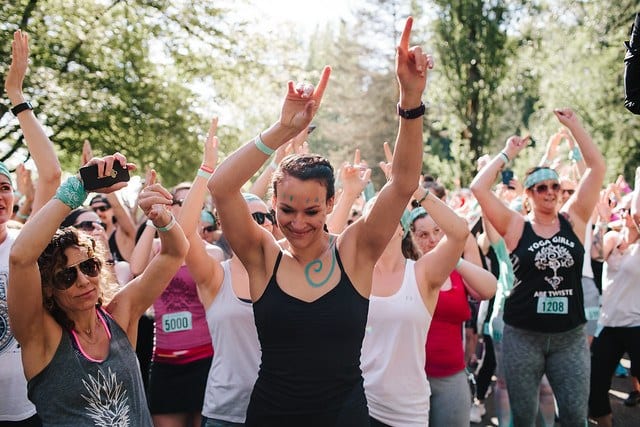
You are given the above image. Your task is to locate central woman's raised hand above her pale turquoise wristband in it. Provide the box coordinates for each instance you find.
[279,66,331,134]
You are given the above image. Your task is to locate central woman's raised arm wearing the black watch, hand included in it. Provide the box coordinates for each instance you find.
[352,17,433,263]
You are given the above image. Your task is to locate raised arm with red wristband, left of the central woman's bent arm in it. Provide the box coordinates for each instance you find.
[178,117,224,309]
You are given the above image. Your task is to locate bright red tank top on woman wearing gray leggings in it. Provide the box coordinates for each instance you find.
[425,270,471,377]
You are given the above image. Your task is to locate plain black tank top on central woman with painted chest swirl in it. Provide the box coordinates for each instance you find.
[246,246,369,427]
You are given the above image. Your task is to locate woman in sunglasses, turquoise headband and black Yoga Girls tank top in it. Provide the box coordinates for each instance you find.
[471,109,606,426]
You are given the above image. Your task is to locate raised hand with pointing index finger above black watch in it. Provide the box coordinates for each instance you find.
[396,17,433,101]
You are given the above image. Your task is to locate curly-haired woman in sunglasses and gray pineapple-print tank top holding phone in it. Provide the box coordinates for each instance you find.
[8,154,188,426]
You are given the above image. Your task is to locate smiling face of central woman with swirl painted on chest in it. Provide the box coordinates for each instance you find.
[273,175,334,248]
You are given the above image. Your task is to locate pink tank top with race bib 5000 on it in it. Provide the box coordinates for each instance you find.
[153,265,213,364]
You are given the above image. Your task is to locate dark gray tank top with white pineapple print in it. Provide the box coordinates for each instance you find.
[28,309,153,427]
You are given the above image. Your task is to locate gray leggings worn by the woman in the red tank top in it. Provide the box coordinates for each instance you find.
[427,369,471,427]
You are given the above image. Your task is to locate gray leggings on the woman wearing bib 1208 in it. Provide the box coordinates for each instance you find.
[502,325,590,427]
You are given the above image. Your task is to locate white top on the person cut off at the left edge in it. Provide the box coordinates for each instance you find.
[0,229,36,421]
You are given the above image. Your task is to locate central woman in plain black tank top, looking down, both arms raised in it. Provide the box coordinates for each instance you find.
[209,15,432,427]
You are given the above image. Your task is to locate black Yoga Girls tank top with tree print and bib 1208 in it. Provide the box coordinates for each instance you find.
[504,215,586,333]
